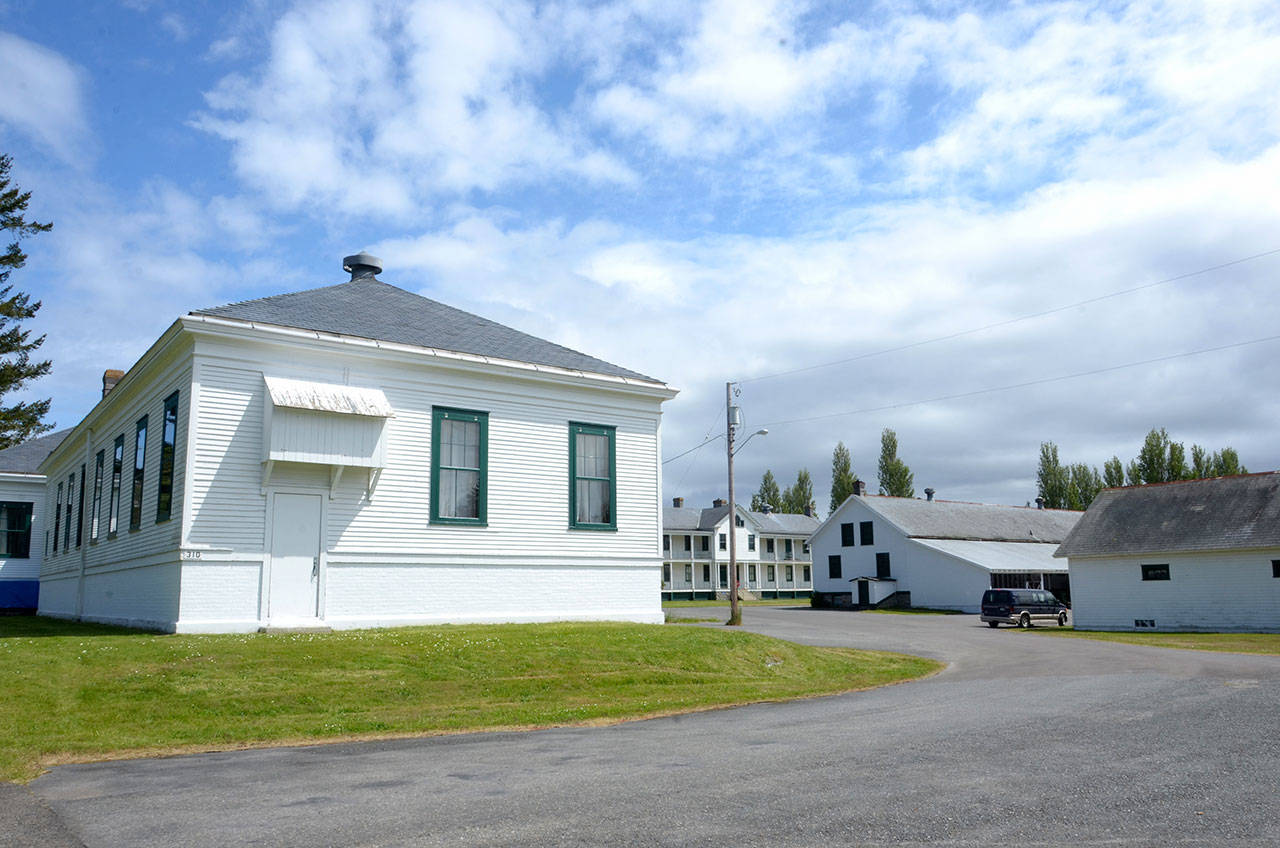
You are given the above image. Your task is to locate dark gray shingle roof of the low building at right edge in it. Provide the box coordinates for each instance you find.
[1056,471,1280,556]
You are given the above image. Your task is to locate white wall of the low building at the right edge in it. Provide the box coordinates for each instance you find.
[1070,548,1280,632]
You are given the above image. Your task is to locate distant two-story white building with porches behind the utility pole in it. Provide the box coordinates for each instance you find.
[662,497,818,601]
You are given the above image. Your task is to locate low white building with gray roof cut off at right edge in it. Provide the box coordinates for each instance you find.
[1057,471,1280,633]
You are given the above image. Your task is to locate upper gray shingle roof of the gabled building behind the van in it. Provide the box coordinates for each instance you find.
[854,494,1082,542]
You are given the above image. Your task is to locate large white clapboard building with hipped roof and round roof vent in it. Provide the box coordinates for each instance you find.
[40,254,675,632]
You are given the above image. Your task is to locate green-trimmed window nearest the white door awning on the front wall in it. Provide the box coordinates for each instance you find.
[431,406,489,525]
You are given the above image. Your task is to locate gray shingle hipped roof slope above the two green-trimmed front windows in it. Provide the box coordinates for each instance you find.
[192,277,659,382]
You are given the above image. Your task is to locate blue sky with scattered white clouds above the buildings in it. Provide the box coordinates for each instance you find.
[0,0,1280,511]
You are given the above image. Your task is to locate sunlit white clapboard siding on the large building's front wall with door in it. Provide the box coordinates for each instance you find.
[188,348,659,560]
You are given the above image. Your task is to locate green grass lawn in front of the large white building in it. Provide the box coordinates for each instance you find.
[0,617,942,780]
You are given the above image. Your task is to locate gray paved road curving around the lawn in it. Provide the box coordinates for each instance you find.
[17,607,1280,847]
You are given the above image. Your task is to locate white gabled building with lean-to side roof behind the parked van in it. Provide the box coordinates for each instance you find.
[809,493,1080,612]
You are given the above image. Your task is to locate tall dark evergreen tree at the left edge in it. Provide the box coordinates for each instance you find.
[0,155,52,448]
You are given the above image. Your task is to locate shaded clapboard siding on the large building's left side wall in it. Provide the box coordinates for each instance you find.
[32,356,191,589]
